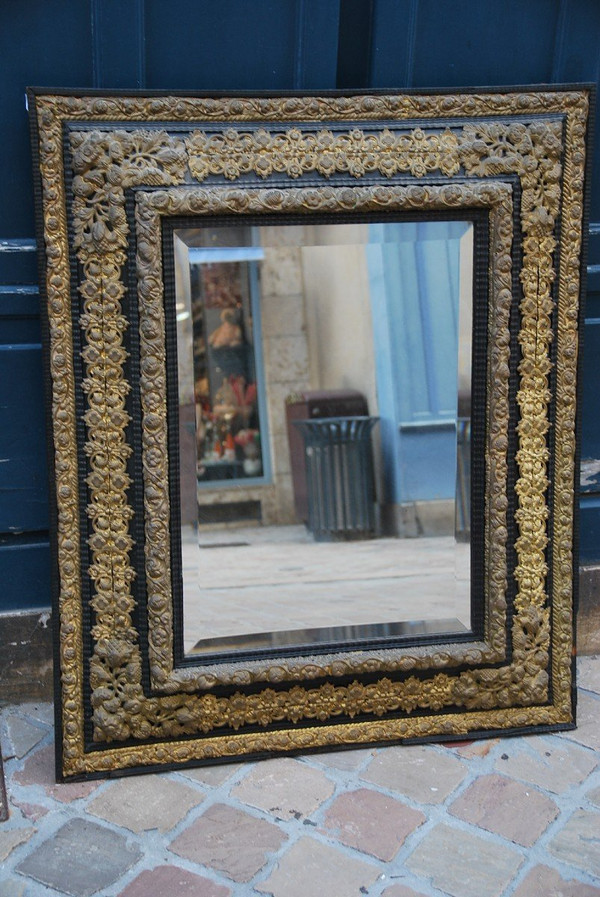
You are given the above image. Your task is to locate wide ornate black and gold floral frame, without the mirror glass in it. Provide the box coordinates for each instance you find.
[30,88,589,777]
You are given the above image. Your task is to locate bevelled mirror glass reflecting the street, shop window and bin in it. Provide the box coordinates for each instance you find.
[174,220,474,658]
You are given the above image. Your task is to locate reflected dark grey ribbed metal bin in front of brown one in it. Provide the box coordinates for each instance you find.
[294,417,379,542]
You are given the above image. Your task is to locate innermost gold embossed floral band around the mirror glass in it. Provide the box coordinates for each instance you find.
[136,181,513,691]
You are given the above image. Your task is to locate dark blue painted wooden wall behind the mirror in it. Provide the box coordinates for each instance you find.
[0,0,600,610]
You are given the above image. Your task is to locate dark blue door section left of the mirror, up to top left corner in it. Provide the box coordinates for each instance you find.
[0,0,93,611]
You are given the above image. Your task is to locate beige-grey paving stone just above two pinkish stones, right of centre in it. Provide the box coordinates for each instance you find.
[360,745,467,804]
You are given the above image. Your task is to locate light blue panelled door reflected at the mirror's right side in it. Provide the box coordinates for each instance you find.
[367,221,469,502]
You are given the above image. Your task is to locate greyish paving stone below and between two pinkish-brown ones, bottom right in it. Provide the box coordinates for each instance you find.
[405,824,523,897]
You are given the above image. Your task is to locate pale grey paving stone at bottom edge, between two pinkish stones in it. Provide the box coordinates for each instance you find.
[254,837,379,897]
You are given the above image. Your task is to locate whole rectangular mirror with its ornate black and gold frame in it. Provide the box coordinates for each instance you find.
[29,88,589,778]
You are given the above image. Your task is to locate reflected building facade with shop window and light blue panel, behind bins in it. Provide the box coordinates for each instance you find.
[174,221,473,538]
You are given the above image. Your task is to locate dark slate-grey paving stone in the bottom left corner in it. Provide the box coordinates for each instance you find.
[16,819,142,897]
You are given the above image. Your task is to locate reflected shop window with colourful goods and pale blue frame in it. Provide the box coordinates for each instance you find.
[177,248,264,483]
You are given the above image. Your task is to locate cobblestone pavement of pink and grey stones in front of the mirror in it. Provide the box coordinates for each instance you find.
[0,658,600,897]
